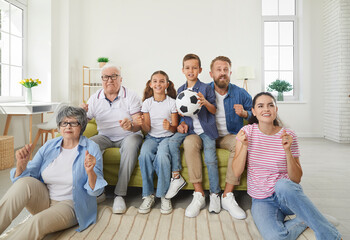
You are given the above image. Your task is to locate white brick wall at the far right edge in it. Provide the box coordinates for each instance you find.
[323,0,350,143]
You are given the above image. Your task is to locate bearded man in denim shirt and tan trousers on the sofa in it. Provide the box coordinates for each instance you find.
[184,56,252,219]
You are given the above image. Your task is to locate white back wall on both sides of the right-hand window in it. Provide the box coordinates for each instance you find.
[67,0,323,137]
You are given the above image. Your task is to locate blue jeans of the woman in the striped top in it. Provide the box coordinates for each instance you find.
[252,179,341,240]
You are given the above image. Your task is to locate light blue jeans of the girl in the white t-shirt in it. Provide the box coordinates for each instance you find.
[139,135,171,198]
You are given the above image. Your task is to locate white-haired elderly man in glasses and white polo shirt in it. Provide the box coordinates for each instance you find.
[81,64,142,213]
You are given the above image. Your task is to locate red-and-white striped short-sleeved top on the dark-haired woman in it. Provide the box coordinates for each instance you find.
[242,123,300,199]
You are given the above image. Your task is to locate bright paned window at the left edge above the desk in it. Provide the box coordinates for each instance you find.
[0,0,24,97]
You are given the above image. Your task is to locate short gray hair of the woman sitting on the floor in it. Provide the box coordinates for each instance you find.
[56,106,88,135]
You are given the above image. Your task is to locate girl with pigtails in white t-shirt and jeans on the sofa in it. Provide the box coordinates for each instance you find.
[136,71,178,214]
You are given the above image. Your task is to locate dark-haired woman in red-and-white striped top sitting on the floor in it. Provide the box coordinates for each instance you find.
[232,92,340,240]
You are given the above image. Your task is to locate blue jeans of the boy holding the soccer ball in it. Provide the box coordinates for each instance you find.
[169,133,221,193]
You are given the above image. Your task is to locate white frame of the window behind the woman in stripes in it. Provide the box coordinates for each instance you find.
[261,1,301,101]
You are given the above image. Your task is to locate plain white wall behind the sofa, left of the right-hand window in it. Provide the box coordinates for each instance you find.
[78,0,261,95]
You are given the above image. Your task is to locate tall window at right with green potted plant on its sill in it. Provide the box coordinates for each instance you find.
[262,0,299,100]
